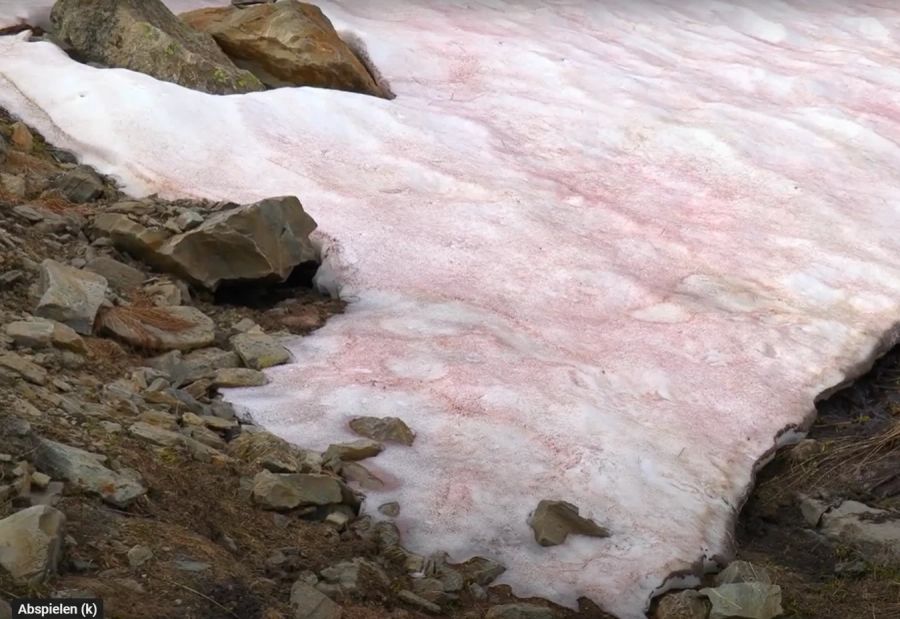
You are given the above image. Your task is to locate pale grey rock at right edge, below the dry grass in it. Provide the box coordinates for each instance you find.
[822,501,900,563]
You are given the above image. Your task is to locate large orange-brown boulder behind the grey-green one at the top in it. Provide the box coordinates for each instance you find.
[181,0,390,98]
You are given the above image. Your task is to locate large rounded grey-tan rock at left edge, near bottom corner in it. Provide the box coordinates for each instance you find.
[0,505,66,585]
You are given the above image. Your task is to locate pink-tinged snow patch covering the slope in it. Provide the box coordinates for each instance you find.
[0,0,900,619]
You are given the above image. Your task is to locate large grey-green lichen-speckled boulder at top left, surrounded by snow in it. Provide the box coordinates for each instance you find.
[50,0,264,94]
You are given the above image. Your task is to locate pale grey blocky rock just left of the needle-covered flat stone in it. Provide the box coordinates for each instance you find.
[34,258,107,335]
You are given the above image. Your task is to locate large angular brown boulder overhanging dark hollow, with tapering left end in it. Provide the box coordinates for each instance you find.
[94,196,318,290]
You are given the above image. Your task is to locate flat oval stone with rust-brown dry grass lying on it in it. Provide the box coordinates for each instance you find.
[98,305,216,350]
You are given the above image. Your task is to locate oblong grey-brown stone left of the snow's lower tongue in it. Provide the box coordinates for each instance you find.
[252,471,344,510]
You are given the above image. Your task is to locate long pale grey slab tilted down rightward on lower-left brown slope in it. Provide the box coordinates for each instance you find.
[35,439,147,507]
